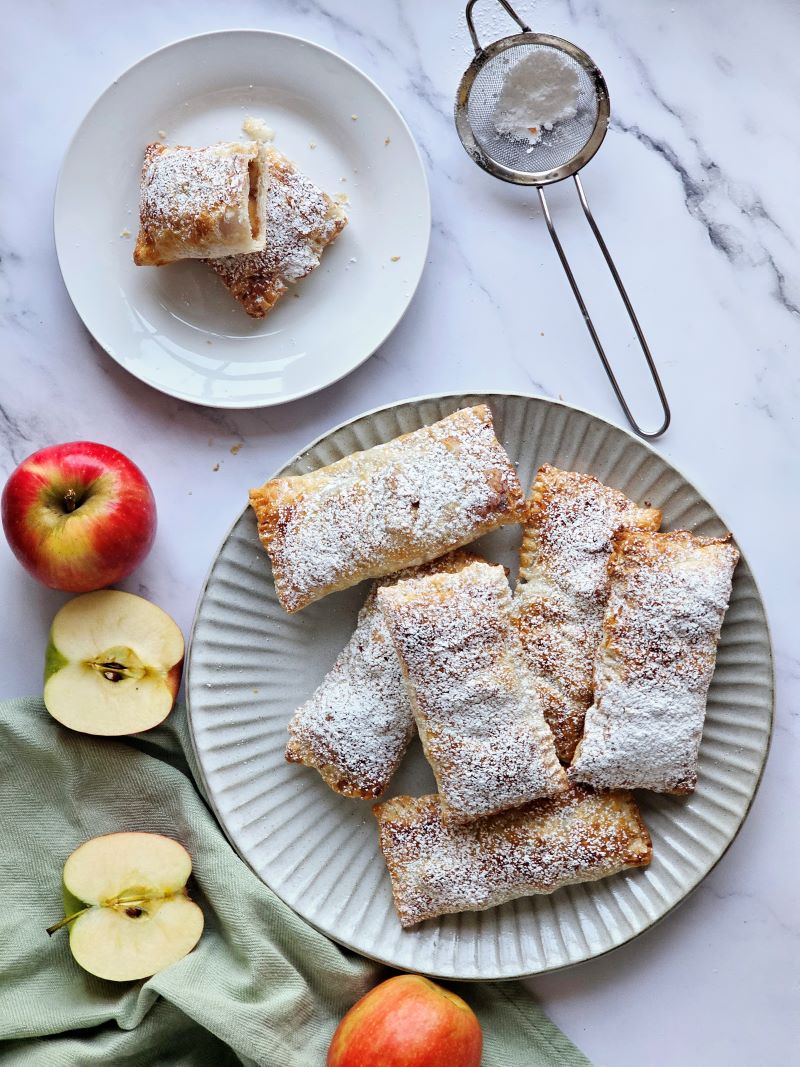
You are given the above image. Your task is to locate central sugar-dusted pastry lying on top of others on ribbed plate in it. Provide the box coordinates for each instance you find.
[378,562,566,823]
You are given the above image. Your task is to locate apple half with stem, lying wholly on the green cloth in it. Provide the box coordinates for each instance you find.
[47,833,204,982]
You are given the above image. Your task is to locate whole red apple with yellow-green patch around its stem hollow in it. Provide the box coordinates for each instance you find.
[0,441,156,593]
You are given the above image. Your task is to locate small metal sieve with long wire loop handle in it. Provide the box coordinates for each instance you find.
[455,0,670,439]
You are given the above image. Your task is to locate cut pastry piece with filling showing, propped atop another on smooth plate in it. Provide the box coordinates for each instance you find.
[133,143,269,267]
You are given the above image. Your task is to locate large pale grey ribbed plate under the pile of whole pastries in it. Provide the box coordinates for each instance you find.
[187,395,772,978]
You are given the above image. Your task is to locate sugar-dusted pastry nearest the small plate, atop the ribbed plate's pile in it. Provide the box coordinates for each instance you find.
[250,404,523,611]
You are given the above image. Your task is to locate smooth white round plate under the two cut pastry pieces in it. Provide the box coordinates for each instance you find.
[54,30,431,408]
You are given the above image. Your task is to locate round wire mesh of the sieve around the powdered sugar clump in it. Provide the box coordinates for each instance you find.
[467,43,597,174]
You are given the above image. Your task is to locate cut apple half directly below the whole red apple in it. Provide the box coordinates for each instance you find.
[44,589,183,737]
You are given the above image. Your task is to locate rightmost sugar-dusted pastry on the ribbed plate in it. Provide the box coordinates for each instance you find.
[569,529,739,793]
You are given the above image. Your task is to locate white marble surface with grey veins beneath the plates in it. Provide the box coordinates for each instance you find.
[0,0,800,1067]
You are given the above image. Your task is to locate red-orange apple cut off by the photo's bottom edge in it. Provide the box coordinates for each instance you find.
[327,974,483,1067]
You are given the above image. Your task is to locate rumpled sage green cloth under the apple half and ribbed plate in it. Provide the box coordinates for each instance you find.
[0,698,589,1067]
